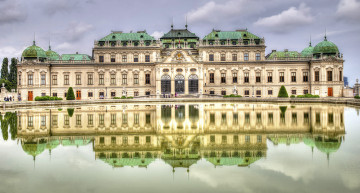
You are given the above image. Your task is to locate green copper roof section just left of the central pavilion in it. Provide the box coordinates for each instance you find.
[99,31,155,41]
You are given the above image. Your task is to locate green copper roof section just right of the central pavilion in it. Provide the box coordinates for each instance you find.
[204,30,260,40]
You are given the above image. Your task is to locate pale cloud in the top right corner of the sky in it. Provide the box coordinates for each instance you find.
[336,0,360,22]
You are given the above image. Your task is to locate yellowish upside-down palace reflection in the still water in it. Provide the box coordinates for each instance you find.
[9,103,345,168]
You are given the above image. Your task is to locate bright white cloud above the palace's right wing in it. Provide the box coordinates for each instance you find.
[254,3,314,32]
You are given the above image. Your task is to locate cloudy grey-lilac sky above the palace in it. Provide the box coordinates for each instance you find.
[0,0,360,85]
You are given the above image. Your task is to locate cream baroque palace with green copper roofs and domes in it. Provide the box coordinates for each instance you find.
[18,26,344,101]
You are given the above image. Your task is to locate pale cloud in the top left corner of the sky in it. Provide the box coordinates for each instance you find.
[0,0,27,25]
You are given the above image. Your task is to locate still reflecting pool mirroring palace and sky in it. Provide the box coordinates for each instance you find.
[0,103,360,193]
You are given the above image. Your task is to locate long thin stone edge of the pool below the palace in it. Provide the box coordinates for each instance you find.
[0,98,360,109]
